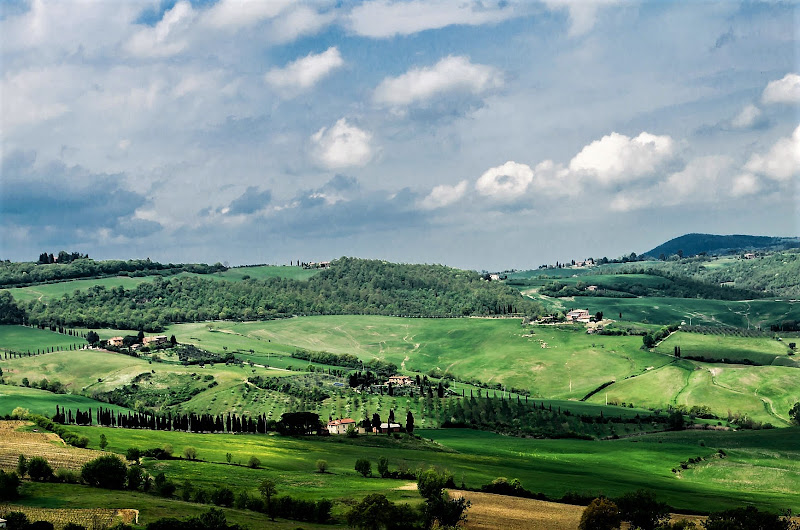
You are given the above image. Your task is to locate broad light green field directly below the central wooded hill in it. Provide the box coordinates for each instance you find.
[168,316,670,399]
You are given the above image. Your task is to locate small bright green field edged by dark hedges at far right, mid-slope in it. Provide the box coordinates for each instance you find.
[656,332,800,368]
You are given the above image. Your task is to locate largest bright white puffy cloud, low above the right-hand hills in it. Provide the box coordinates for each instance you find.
[569,132,675,185]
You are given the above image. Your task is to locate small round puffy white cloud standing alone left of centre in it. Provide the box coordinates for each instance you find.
[311,118,372,169]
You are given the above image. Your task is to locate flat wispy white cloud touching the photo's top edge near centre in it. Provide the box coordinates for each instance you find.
[346,0,516,38]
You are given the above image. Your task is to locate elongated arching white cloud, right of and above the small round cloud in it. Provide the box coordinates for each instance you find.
[374,56,503,106]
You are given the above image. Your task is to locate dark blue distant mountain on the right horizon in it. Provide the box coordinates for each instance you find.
[644,234,800,258]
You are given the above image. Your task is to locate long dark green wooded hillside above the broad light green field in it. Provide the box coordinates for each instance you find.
[21,258,539,331]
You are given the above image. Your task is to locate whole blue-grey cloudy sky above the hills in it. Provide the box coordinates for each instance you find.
[0,0,800,270]
